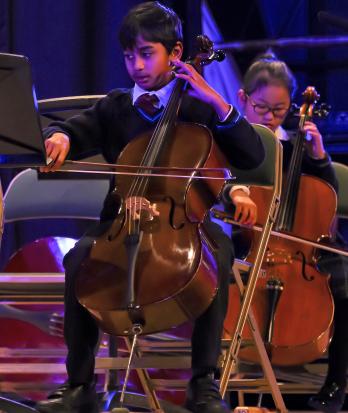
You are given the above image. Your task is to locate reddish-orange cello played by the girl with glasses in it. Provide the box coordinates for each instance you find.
[225,87,337,366]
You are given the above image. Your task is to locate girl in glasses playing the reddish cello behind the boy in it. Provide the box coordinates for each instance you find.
[225,54,348,413]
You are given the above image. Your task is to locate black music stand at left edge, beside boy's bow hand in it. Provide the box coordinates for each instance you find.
[0,53,46,168]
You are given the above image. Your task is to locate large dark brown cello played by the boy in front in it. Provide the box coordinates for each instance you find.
[76,35,227,335]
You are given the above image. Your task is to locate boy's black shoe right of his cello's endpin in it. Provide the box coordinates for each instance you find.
[185,374,231,413]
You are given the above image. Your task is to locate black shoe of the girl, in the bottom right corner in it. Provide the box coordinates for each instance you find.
[308,383,346,413]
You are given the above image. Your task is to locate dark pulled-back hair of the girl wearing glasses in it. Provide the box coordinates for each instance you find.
[243,52,297,99]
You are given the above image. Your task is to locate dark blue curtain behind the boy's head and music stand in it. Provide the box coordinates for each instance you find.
[0,0,200,99]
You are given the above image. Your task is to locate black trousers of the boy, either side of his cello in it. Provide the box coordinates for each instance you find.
[64,221,234,385]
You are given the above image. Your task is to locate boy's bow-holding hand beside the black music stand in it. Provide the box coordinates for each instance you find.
[40,132,70,172]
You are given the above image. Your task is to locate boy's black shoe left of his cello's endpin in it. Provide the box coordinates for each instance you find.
[36,384,99,413]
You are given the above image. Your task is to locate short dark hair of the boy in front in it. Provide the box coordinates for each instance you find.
[119,1,183,53]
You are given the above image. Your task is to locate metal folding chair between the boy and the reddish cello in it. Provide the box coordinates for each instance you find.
[213,125,286,412]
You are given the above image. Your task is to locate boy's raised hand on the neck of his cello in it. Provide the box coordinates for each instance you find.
[172,60,230,120]
